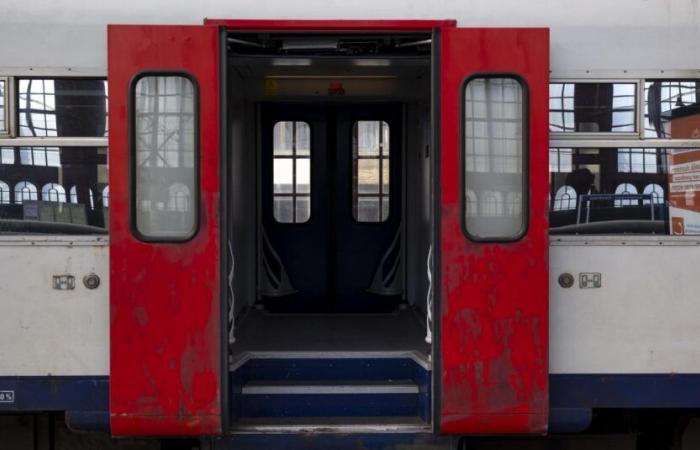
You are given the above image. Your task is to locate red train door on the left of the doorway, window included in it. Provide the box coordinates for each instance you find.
[108,25,222,436]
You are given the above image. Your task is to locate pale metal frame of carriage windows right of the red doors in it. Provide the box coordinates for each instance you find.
[549,69,700,241]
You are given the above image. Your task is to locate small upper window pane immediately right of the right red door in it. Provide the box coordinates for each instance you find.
[549,82,637,133]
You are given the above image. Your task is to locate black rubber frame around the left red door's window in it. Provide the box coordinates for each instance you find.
[129,69,201,244]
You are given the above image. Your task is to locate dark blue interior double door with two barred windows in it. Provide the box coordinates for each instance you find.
[259,104,403,313]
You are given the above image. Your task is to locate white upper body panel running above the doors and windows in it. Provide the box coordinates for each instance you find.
[0,0,700,71]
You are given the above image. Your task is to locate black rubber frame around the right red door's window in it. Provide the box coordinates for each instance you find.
[458,72,530,244]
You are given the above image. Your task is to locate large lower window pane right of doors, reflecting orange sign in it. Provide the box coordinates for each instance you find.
[550,148,688,234]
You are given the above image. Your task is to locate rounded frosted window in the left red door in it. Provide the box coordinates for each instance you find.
[131,73,199,241]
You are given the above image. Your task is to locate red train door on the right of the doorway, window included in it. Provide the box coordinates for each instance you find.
[436,27,549,434]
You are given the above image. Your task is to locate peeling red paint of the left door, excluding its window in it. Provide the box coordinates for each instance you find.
[108,26,222,436]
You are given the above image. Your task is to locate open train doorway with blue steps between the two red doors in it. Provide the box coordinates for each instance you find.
[226,33,433,428]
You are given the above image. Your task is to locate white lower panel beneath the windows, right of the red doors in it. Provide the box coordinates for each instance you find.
[550,238,700,374]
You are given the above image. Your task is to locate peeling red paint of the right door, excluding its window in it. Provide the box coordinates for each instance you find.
[439,28,549,434]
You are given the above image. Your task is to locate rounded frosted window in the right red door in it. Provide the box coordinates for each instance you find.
[462,75,528,241]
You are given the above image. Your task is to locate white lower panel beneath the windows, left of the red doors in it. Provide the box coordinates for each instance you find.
[0,236,109,376]
